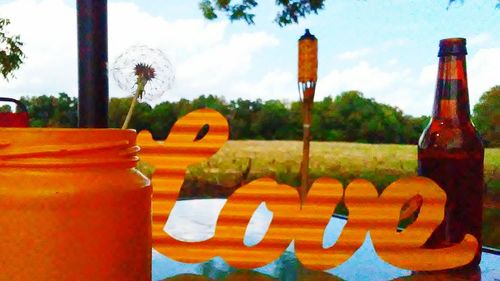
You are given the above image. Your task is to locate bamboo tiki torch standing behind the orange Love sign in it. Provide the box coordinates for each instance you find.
[298,29,318,206]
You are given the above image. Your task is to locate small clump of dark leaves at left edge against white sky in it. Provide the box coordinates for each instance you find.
[0,18,25,80]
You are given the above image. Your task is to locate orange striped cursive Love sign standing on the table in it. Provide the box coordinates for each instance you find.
[138,109,478,271]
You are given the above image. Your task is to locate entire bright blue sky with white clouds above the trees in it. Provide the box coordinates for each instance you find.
[0,0,500,116]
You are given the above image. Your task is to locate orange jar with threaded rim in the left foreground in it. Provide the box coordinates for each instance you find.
[0,128,151,281]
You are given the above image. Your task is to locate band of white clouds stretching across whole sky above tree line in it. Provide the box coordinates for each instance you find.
[0,0,500,118]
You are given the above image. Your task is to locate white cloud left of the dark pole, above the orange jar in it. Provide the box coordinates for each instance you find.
[0,0,78,97]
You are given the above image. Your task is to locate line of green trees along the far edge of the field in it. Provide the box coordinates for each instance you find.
[0,86,500,146]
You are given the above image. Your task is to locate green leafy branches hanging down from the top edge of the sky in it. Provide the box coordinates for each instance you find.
[199,0,500,27]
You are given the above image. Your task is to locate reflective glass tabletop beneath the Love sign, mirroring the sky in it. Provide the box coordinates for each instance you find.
[153,199,500,281]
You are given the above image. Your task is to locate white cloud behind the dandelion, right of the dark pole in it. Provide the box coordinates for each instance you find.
[109,3,278,103]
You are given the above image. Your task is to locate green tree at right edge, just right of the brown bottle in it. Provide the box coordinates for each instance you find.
[472,85,500,147]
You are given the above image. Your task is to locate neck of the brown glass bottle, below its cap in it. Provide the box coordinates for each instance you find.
[432,55,470,123]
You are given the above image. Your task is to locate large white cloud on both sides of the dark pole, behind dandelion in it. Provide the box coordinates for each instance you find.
[0,0,279,103]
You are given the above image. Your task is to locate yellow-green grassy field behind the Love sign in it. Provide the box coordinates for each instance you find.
[146,141,500,248]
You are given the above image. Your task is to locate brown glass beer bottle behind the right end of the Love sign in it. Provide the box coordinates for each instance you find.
[418,38,484,267]
